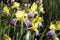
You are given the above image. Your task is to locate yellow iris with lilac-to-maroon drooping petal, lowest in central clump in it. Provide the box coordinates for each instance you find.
[25,20,42,31]
